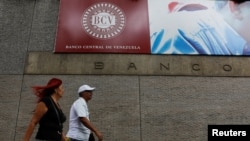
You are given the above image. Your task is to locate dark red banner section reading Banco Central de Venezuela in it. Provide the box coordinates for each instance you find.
[55,0,150,54]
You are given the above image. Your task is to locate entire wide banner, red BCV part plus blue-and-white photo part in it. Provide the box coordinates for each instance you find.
[55,0,250,55]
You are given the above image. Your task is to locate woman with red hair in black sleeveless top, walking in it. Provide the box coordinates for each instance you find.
[23,78,66,141]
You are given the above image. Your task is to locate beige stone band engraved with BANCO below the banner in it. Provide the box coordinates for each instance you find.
[25,52,250,76]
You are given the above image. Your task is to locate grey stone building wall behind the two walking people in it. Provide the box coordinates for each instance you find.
[0,0,250,141]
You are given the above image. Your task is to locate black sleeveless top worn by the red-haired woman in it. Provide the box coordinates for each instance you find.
[36,97,66,141]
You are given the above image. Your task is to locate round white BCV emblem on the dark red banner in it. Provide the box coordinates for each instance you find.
[81,2,126,40]
